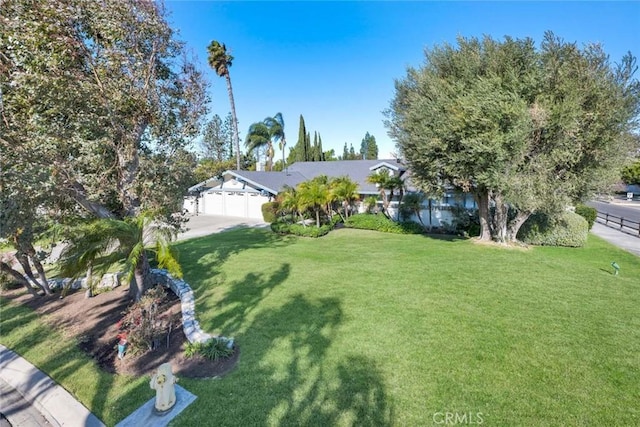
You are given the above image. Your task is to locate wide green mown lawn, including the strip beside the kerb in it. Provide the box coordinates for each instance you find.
[0,229,640,426]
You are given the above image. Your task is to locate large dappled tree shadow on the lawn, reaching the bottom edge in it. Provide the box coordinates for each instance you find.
[180,280,393,427]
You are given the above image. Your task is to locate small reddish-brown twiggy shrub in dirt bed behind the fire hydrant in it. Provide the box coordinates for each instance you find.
[118,286,173,354]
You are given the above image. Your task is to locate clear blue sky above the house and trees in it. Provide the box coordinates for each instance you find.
[166,0,640,159]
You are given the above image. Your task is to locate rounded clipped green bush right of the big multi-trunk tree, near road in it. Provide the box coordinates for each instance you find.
[518,211,589,247]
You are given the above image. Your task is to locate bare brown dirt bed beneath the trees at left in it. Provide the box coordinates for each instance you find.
[2,286,240,378]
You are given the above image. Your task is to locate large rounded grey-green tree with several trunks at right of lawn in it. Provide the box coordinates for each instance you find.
[386,32,640,242]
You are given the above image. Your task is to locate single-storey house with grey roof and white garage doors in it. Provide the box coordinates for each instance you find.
[184,159,475,227]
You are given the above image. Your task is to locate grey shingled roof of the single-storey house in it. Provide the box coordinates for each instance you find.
[198,159,407,194]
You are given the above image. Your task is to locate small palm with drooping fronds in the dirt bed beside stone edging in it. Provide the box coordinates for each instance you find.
[60,214,182,301]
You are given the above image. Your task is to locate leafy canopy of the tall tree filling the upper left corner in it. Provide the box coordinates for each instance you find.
[0,0,207,300]
